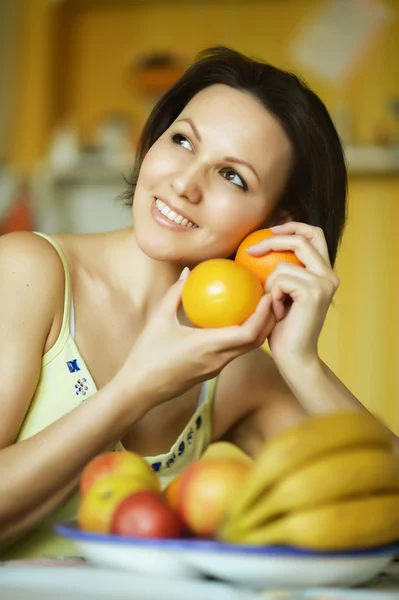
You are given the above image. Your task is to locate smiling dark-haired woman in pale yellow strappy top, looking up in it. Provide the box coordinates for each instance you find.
[0,48,396,559]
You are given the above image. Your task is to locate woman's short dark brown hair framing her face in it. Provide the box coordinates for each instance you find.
[122,46,347,264]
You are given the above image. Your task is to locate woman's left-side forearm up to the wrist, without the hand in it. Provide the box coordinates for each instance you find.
[0,381,147,542]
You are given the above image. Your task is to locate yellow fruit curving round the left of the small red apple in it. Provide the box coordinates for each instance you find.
[78,475,159,533]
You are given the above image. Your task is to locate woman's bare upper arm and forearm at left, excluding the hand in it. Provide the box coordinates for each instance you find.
[0,233,151,541]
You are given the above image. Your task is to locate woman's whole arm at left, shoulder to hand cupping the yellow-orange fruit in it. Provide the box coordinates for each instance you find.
[0,233,276,542]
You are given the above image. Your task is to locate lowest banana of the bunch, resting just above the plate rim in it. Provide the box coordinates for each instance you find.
[234,494,399,551]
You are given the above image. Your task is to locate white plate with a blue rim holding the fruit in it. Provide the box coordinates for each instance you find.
[55,521,399,590]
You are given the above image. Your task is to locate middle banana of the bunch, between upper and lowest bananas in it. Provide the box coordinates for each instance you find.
[221,446,399,541]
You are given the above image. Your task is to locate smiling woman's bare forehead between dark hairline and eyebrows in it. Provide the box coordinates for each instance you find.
[177,84,291,177]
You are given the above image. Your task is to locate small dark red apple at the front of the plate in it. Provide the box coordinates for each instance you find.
[111,491,183,538]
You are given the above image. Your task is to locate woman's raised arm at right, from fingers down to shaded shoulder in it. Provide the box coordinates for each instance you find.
[214,223,399,454]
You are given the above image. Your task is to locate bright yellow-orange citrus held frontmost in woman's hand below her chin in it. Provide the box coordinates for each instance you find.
[182,258,263,327]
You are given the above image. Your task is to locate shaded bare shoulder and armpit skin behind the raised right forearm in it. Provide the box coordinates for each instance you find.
[213,348,306,454]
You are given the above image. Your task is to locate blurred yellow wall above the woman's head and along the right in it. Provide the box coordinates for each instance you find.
[11,0,399,431]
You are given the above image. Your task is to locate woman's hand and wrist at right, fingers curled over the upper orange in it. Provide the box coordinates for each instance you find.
[250,222,339,366]
